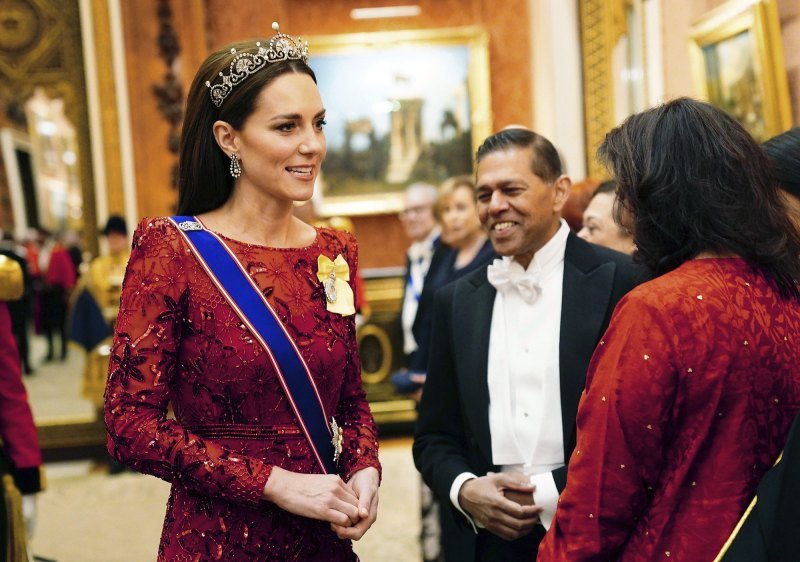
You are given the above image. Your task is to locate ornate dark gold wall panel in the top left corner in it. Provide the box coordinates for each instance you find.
[0,0,97,246]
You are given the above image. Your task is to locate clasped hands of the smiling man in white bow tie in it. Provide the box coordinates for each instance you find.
[458,472,543,541]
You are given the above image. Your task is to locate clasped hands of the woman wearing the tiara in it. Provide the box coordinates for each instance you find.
[263,466,378,540]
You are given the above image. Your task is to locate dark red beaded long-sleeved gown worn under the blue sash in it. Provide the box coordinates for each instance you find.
[105,218,380,562]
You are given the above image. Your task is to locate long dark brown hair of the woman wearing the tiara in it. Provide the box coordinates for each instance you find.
[178,40,317,215]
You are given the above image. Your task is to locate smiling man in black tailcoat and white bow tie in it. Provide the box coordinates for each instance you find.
[414,129,641,561]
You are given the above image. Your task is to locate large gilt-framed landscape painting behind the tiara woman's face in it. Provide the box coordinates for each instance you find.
[307,27,492,216]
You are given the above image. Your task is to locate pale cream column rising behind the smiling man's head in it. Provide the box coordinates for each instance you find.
[528,0,586,181]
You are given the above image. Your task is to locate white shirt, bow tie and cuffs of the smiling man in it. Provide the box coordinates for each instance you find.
[450,220,569,529]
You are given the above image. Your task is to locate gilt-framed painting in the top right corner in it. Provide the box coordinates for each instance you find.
[689,0,792,141]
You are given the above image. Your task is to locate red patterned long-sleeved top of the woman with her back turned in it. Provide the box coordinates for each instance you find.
[538,258,800,562]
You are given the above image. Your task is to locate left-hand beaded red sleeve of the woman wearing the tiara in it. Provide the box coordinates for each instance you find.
[105,219,272,506]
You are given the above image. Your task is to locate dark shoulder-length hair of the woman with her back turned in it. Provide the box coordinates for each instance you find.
[598,98,800,297]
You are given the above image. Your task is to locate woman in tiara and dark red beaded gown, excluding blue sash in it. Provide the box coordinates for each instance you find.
[105,24,380,562]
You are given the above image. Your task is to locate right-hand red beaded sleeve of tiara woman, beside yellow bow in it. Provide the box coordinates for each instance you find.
[336,236,381,481]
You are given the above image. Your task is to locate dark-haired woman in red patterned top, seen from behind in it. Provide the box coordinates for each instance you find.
[538,98,800,562]
